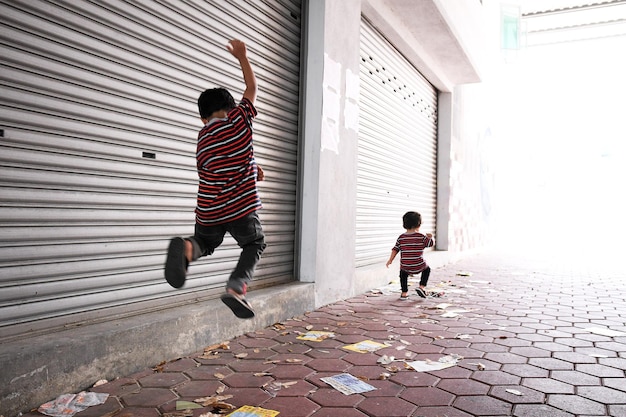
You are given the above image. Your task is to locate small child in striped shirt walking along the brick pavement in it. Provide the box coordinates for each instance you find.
[387,211,435,300]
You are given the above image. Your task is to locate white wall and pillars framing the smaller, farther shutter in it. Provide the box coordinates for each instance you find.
[298,0,499,306]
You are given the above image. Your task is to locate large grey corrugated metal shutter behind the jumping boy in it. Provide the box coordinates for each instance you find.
[0,0,301,336]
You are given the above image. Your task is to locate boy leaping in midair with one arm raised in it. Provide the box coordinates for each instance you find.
[165,39,266,318]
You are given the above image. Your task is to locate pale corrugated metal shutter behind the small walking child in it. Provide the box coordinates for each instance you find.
[356,20,437,267]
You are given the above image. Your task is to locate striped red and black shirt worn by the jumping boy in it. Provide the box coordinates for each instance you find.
[196,98,261,225]
